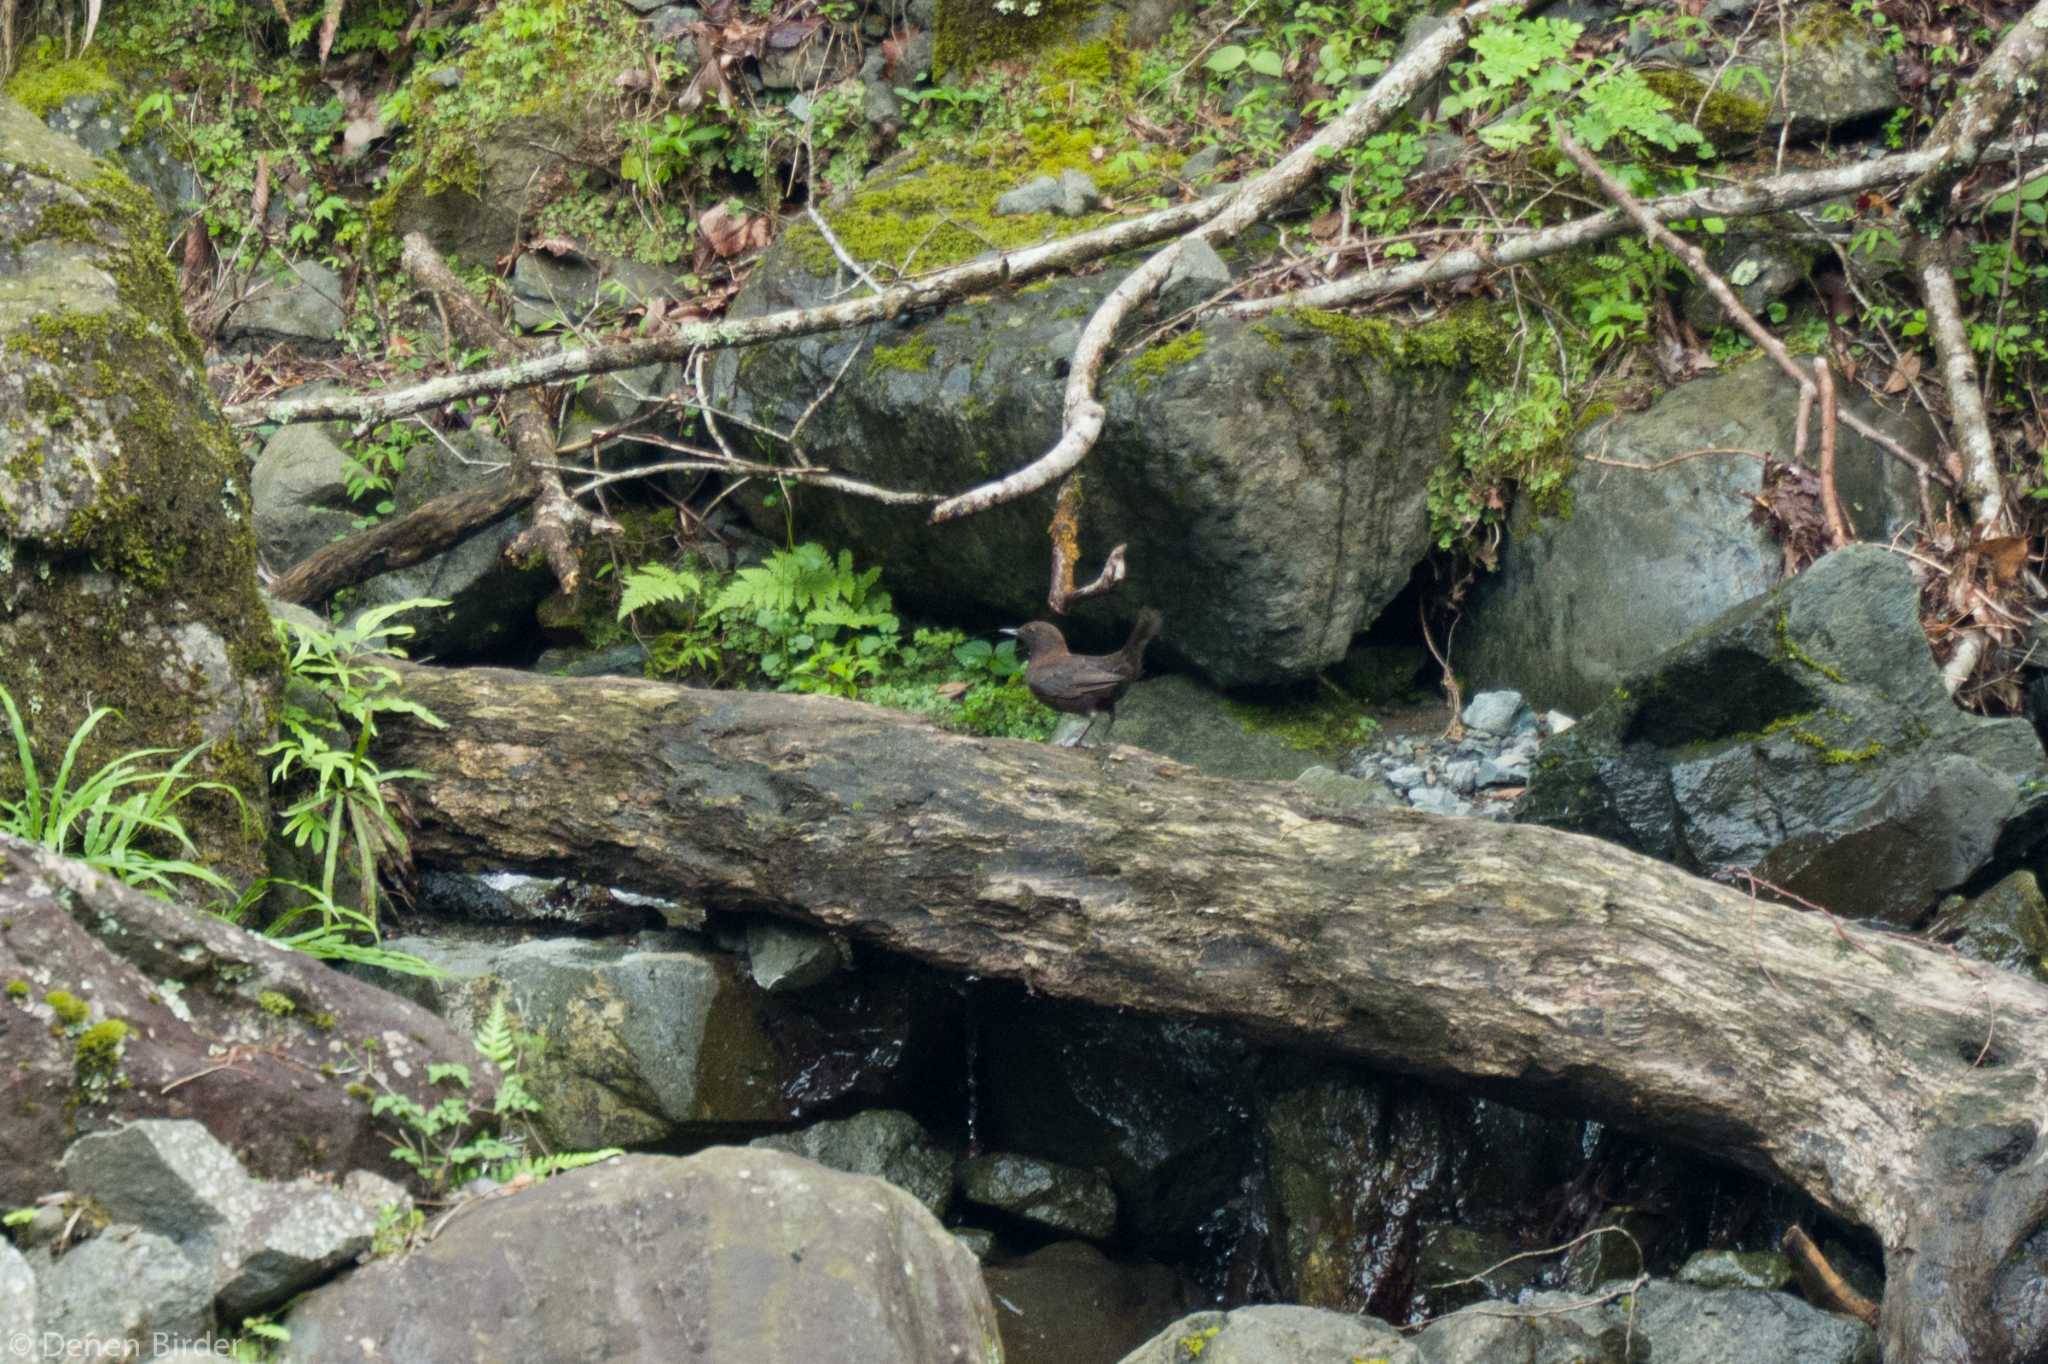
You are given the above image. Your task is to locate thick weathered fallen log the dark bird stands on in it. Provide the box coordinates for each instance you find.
[379,668,2048,1364]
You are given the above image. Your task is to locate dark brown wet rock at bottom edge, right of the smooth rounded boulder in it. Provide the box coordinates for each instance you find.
[981,1241,1198,1364]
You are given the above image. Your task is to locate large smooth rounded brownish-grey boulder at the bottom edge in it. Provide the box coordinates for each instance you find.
[279,1147,1001,1364]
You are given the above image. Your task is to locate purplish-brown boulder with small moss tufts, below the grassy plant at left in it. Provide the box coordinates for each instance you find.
[0,836,489,1208]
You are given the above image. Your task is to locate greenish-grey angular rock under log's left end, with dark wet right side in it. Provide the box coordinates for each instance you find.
[373,934,933,1149]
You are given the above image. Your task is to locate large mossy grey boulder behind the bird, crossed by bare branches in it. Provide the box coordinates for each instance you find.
[713,193,1483,686]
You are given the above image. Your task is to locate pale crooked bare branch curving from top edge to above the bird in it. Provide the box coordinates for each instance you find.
[932,0,1524,522]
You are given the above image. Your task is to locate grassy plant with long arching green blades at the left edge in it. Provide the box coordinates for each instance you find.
[0,686,248,899]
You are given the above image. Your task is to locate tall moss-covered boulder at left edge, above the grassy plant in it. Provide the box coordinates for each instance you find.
[0,98,279,875]
